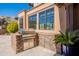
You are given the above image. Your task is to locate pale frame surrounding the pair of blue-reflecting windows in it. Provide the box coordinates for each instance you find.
[28,4,55,33]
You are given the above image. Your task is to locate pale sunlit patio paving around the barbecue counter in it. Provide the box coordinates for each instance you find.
[0,35,55,56]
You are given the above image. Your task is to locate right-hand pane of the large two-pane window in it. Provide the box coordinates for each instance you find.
[46,8,54,30]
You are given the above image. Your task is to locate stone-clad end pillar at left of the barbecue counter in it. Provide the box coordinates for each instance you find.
[11,33,24,53]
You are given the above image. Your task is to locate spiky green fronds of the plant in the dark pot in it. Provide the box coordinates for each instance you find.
[54,31,79,45]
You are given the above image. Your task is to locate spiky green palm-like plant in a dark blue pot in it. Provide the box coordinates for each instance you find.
[54,31,78,56]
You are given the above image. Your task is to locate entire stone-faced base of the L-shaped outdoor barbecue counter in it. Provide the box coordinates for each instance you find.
[11,33,61,53]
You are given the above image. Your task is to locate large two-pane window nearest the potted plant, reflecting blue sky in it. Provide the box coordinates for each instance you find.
[39,8,54,30]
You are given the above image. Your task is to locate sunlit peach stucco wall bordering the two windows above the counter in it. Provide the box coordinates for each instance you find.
[26,3,60,33]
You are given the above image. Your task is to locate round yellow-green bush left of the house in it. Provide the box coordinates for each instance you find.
[7,21,18,33]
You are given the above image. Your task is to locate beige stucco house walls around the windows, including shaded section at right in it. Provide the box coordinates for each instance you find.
[18,3,76,33]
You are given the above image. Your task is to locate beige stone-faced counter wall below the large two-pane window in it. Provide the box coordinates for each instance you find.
[39,34,61,53]
